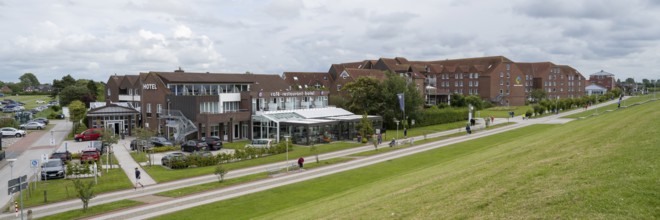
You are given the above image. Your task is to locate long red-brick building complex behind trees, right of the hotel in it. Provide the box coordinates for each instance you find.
[320,56,585,105]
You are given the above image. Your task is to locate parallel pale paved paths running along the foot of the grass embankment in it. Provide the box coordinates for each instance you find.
[0,98,632,219]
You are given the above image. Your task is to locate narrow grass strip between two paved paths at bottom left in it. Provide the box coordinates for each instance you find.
[39,200,144,220]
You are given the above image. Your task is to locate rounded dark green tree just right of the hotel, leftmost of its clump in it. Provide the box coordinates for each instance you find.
[342,77,383,114]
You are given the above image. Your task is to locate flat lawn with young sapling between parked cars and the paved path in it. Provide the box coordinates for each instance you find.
[15,169,133,207]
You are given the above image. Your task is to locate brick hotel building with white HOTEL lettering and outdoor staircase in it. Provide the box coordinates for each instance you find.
[106,69,379,144]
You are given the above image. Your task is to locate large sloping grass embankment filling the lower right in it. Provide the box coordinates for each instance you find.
[159,101,660,219]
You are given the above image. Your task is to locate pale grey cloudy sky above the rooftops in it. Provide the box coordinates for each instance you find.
[0,0,660,83]
